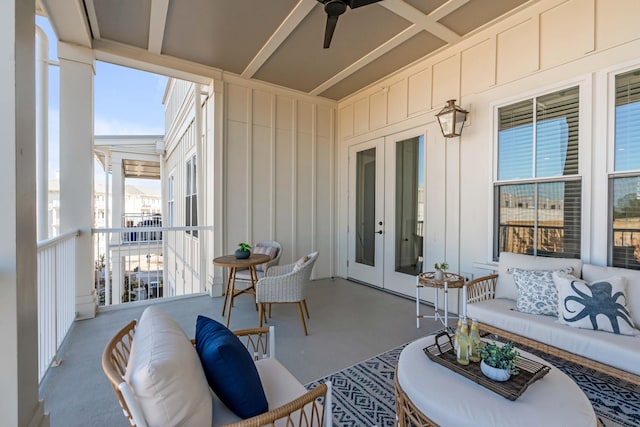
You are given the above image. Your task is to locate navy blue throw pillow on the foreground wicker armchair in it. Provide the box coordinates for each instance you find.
[196,316,269,419]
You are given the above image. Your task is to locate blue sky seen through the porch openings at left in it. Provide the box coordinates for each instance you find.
[36,16,167,187]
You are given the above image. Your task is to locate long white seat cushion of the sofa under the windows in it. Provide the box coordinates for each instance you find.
[467,299,640,375]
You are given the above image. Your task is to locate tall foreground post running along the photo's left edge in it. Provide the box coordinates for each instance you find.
[0,0,49,426]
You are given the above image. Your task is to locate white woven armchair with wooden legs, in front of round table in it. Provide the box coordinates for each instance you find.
[256,252,318,335]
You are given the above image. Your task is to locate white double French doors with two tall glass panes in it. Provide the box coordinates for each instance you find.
[348,130,426,294]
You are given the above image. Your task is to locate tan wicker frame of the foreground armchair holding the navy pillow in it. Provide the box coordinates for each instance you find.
[102,320,333,427]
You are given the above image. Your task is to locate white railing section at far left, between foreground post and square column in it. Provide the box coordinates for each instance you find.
[37,231,80,381]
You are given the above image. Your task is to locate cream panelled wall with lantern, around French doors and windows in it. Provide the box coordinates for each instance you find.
[336,0,640,300]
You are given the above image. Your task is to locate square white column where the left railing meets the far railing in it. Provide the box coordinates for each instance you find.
[58,43,96,319]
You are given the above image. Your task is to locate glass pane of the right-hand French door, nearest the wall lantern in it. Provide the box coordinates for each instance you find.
[395,136,424,275]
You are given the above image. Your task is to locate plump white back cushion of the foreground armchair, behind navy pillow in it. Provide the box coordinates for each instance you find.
[125,306,212,427]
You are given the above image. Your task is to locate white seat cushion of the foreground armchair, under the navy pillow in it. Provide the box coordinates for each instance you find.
[211,358,307,427]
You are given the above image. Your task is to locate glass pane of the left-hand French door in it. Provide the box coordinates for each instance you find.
[356,148,376,266]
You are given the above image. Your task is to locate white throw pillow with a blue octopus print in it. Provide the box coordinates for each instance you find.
[553,273,640,335]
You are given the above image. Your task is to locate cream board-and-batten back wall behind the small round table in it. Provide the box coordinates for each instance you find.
[222,74,336,278]
